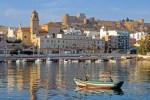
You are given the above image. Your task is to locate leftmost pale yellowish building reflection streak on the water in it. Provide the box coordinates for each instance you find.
[7,68,15,91]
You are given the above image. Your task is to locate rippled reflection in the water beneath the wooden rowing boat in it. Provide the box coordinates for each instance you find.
[74,87,124,96]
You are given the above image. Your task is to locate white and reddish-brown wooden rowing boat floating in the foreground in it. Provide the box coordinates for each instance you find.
[74,78,124,89]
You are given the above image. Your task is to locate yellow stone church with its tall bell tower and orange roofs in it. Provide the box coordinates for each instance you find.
[17,10,60,46]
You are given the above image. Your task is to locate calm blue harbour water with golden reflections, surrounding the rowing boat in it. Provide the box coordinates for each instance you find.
[0,60,150,100]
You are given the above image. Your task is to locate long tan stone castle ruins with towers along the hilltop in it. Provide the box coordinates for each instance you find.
[62,13,148,32]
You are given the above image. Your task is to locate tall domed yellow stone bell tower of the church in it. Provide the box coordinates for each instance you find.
[30,10,39,44]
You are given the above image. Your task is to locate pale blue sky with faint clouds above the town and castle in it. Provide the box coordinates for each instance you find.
[0,0,150,27]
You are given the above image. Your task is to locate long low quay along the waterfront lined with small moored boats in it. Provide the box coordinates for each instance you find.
[0,53,137,61]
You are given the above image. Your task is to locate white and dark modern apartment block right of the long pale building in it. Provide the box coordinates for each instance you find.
[100,26,129,52]
